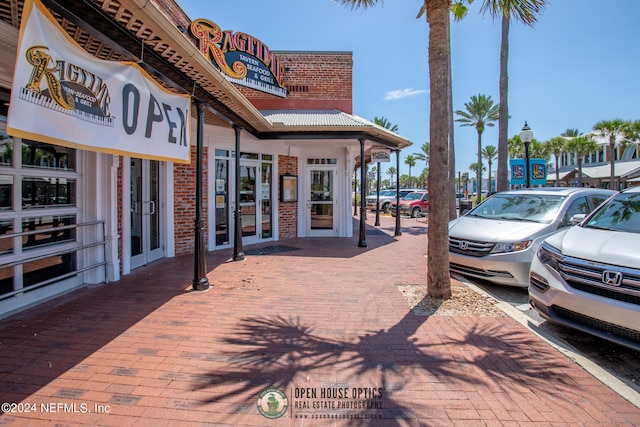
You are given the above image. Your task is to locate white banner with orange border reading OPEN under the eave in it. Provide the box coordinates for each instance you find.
[7,0,191,163]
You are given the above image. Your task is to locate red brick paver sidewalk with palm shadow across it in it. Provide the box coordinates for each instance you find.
[0,215,640,427]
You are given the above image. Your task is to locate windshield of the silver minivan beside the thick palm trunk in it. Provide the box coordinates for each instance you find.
[467,193,564,223]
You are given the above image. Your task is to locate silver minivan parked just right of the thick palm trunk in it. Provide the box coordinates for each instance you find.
[449,187,615,288]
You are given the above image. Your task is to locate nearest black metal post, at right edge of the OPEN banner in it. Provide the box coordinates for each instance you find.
[192,102,209,291]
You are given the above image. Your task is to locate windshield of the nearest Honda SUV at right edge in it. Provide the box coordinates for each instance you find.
[583,193,640,233]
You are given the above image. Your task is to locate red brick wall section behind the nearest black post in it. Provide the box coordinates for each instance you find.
[174,145,208,255]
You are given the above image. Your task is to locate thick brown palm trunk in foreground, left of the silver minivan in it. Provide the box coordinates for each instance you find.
[425,0,451,299]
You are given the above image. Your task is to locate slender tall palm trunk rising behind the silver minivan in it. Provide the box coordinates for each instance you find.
[496,14,509,191]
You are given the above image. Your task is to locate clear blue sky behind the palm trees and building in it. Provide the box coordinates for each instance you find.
[178,0,640,175]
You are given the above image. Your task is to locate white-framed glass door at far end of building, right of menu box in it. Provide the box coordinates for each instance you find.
[307,166,337,236]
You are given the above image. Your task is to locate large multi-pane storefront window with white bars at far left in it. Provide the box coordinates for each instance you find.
[0,120,80,298]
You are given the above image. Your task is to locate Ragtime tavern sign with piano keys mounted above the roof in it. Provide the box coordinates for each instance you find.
[189,18,287,98]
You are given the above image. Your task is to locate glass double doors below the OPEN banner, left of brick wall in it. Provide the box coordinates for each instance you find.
[130,159,164,269]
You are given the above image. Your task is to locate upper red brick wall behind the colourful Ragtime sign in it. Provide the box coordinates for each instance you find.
[236,51,353,114]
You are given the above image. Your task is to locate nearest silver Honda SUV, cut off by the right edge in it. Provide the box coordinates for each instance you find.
[529,187,640,351]
